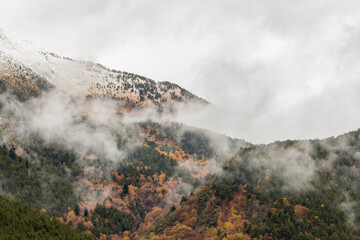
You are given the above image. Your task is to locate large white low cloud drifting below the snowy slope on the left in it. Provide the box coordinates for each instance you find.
[2,90,141,162]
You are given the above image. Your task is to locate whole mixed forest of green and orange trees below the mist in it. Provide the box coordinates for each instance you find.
[0,122,360,240]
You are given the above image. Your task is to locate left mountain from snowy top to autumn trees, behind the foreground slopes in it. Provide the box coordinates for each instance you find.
[0,33,243,238]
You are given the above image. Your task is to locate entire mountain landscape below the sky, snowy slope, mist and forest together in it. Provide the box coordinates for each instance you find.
[0,28,360,240]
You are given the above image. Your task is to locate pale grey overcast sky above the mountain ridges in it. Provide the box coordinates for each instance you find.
[0,0,360,142]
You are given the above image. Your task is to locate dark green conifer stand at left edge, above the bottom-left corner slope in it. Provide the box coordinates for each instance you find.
[0,146,77,216]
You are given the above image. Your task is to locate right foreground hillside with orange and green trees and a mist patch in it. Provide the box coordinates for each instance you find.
[144,130,360,239]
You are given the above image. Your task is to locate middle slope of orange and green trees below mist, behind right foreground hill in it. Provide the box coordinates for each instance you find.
[0,119,250,238]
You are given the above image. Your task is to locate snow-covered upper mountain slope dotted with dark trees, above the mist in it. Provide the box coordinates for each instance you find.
[0,30,205,106]
